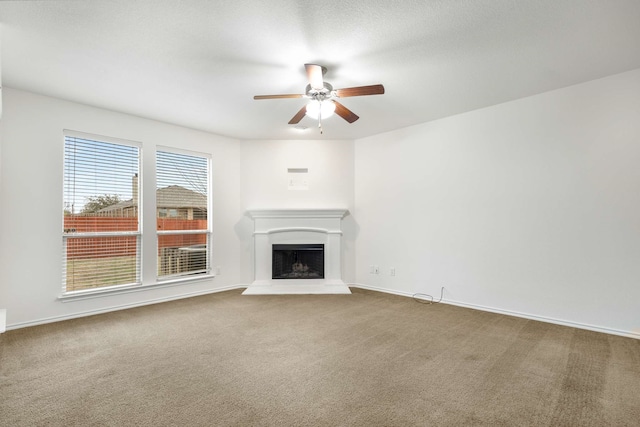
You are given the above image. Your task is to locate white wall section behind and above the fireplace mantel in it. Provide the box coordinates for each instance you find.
[239,140,357,283]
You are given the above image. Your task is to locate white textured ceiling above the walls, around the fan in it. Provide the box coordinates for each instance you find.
[0,0,640,139]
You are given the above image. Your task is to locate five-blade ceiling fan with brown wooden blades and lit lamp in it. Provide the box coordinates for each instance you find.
[253,64,384,133]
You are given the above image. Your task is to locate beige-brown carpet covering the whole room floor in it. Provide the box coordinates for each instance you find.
[0,289,640,426]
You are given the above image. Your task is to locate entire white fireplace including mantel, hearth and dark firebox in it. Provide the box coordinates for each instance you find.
[243,209,351,295]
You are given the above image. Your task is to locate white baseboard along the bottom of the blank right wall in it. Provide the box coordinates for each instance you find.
[349,283,640,339]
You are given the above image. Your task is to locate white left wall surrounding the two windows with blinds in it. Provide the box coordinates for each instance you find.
[0,88,242,327]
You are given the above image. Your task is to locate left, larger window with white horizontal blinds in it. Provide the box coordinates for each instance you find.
[62,132,141,292]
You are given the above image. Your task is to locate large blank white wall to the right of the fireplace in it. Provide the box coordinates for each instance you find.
[354,70,640,337]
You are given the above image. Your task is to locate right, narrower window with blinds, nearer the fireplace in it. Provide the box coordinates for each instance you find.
[156,150,211,279]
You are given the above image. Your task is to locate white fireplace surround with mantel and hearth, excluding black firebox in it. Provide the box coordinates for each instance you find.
[243,209,351,295]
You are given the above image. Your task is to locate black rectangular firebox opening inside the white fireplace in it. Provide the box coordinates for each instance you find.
[271,244,324,279]
